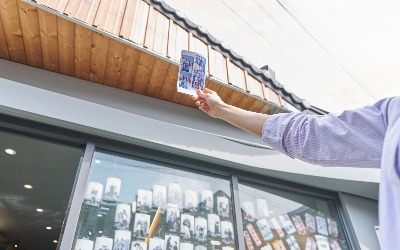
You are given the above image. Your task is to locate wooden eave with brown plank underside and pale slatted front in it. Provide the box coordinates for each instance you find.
[0,0,294,114]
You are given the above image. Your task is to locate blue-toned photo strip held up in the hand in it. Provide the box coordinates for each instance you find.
[177,50,207,95]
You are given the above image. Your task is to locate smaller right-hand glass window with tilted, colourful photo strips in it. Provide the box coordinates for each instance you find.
[239,184,349,250]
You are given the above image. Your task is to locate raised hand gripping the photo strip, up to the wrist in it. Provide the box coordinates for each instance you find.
[192,88,226,118]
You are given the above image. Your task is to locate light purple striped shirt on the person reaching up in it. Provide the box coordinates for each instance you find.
[262,97,400,250]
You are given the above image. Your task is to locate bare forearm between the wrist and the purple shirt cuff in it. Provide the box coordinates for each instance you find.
[217,104,268,137]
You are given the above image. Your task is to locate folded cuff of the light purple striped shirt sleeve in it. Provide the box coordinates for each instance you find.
[262,113,297,158]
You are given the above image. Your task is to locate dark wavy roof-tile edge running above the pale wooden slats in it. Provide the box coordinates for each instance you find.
[145,0,311,110]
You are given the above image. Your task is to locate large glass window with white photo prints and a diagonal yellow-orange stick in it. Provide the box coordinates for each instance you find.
[73,151,235,250]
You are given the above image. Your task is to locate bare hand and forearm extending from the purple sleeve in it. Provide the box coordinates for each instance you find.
[192,89,268,137]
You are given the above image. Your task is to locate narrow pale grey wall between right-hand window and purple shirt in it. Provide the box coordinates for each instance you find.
[339,193,380,250]
